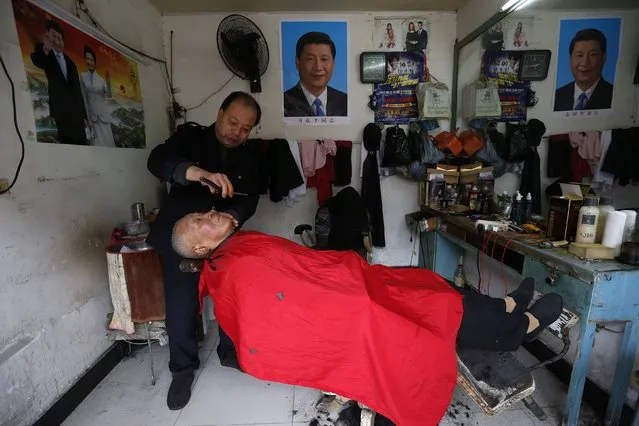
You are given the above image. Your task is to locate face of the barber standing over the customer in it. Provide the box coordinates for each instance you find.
[215,100,257,148]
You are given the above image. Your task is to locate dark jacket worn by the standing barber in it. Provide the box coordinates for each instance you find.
[147,123,260,255]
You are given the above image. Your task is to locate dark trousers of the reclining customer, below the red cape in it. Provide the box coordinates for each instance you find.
[454,287,528,351]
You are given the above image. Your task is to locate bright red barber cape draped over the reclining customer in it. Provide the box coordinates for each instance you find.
[200,231,462,426]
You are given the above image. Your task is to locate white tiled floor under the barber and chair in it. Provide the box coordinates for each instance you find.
[63,327,599,426]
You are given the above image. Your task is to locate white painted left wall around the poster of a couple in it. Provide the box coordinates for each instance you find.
[0,0,169,426]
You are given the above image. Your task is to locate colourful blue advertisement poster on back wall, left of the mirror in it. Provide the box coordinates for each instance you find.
[375,52,428,124]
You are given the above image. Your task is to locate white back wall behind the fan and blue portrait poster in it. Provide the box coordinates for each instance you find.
[164,12,456,265]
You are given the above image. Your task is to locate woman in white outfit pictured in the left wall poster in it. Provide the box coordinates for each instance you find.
[80,46,115,148]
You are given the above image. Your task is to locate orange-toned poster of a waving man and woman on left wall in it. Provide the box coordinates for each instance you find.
[12,1,146,148]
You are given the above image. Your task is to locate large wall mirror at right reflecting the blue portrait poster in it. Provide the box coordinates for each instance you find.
[451,0,639,215]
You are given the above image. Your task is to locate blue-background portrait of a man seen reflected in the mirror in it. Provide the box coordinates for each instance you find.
[553,18,621,118]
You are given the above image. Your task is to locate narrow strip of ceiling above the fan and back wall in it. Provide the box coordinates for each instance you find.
[150,0,469,15]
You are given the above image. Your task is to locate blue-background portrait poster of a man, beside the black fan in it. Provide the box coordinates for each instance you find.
[281,21,350,125]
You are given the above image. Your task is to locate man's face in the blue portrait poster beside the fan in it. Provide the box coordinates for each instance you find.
[295,44,335,91]
